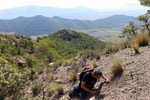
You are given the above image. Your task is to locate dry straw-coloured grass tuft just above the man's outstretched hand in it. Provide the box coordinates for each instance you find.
[111,57,123,77]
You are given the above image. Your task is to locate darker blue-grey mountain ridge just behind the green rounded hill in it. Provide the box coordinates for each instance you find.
[0,15,135,36]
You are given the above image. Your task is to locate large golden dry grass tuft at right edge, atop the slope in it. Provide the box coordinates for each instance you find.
[132,33,150,46]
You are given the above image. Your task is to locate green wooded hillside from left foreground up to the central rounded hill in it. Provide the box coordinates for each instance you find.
[0,30,105,100]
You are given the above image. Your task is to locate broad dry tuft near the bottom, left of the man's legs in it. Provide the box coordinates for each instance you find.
[48,82,64,96]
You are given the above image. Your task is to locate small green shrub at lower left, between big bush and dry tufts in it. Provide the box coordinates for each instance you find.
[32,81,42,95]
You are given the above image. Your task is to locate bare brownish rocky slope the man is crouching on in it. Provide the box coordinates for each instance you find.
[55,46,150,100]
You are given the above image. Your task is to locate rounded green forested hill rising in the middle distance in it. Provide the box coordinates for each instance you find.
[40,29,105,59]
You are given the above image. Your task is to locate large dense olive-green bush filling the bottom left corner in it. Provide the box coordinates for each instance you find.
[0,58,30,100]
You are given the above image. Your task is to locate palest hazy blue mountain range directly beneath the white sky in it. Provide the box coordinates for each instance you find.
[0,4,146,20]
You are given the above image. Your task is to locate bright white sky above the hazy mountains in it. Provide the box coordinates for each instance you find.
[0,0,143,10]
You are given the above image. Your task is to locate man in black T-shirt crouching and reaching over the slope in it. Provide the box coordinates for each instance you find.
[69,69,110,99]
